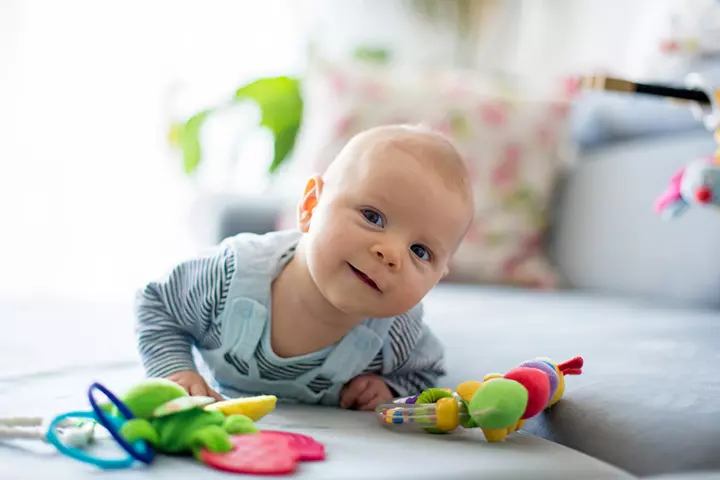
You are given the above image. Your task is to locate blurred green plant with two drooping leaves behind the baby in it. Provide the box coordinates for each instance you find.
[169,76,303,175]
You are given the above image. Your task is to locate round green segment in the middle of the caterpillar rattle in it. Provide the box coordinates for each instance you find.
[470,378,528,430]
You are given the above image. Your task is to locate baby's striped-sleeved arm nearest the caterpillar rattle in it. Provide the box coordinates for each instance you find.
[383,305,446,397]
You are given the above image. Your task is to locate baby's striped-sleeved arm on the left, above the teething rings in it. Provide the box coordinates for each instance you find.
[136,247,235,393]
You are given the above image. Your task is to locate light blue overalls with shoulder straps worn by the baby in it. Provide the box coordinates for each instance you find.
[198,231,393,405]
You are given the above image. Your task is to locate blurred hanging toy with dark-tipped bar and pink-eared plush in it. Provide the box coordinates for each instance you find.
[580,74,720,219]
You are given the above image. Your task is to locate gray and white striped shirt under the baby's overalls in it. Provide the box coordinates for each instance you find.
[136,242,445,396]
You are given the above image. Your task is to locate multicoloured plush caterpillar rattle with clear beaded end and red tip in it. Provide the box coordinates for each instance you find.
[376,357,583,442]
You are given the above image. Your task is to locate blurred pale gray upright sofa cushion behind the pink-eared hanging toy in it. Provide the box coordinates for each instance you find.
[550,131,720,307]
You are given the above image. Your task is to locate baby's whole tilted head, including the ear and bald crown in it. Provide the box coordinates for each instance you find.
[298,126,474,318]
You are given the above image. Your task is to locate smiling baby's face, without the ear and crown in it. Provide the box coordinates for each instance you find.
[306,139,471,318]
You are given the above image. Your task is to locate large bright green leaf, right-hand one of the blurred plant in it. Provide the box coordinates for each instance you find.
[235,76,303,173]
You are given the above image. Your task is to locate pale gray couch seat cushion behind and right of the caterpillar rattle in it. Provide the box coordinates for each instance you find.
[426,286,720,475]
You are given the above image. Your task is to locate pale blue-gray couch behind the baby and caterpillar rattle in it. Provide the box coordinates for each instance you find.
[201,95,720,477]
